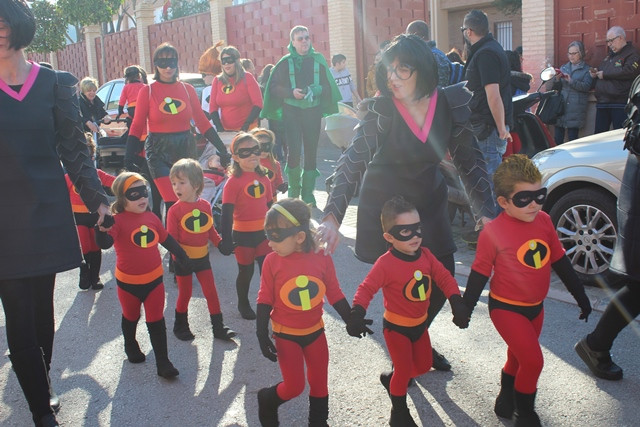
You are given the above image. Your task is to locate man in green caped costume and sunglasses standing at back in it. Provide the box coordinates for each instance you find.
[260,25,342,206]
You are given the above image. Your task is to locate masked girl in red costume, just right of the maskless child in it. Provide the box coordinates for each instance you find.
[218,132,272,320]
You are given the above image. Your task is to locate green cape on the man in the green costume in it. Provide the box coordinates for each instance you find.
[260,42,342,121]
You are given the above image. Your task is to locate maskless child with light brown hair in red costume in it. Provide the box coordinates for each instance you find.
[167,159,236,341]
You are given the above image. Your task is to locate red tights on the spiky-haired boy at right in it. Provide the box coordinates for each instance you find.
[490,309,544,394]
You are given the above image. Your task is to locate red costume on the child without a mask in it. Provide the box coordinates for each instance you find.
[167,199,221,314]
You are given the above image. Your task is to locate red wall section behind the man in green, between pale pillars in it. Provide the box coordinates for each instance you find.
[225,0,331,73]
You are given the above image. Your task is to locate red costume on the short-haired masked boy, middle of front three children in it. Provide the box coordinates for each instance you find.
[352,247,460,396]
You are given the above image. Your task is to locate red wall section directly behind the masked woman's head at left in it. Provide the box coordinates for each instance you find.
[147,12,213,74]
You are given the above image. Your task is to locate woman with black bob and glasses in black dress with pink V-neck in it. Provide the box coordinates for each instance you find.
[318,34,494,381]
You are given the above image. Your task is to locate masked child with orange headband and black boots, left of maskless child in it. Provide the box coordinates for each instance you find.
[96,172,190,379]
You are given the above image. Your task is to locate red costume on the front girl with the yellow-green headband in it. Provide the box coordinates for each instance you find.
[258,252,348,400]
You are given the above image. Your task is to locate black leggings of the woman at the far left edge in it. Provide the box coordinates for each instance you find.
[0,274,56,371]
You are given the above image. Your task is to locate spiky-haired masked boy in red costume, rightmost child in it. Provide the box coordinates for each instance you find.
[458,154,591,426]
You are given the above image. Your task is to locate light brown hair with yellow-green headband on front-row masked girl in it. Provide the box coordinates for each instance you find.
[264,198,316,252]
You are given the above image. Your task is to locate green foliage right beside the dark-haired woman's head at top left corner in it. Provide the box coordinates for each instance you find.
[27,0,67,53]
